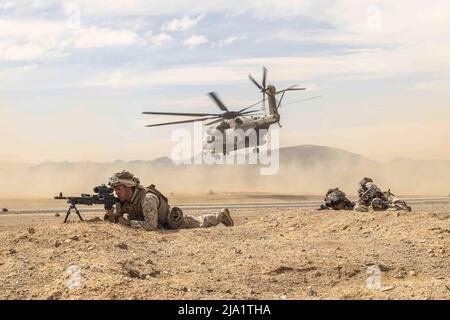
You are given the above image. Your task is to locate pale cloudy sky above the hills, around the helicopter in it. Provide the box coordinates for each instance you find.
[0,0,450,163]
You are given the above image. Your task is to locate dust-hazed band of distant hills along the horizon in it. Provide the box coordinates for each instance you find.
[0,145,450,198]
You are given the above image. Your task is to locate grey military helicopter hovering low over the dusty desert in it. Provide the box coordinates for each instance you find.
[142,67,316,155]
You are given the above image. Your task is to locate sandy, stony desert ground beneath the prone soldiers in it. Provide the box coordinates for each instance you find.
[0,195,450,299]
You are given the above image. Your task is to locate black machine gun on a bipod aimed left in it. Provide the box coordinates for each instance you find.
[54,184,119,223]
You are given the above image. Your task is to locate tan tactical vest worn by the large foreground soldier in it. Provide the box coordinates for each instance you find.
[116,185,170,226]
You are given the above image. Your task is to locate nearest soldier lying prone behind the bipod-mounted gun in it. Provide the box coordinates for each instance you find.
[105,171,234,230]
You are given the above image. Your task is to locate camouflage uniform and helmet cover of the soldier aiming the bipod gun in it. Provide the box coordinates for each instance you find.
[110,172,234,230]
